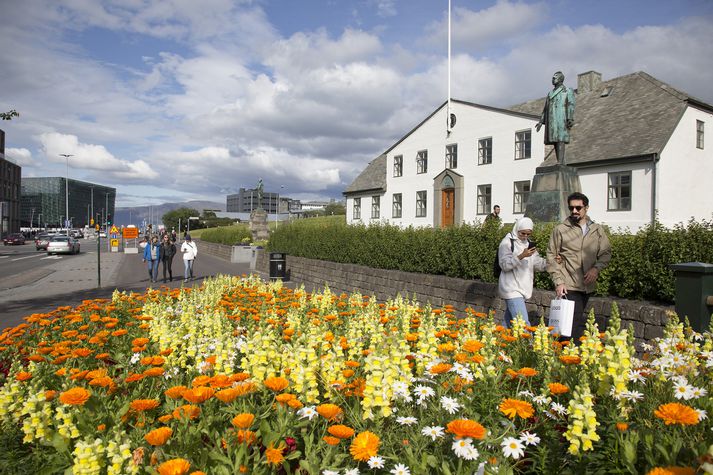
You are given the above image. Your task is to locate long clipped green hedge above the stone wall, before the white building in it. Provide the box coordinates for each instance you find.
[268,216,713,303]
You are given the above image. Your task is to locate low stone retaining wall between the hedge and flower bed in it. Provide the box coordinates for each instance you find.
[257,252,674,349]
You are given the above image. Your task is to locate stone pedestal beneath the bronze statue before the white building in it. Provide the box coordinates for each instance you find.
[525,164,582,222]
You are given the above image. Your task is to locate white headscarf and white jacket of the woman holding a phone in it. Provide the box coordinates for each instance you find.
[498,218,547,299]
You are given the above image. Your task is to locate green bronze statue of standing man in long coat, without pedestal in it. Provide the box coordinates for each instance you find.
[535,71,575,165]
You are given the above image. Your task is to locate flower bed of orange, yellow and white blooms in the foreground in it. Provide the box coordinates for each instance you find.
[0,277,713,474]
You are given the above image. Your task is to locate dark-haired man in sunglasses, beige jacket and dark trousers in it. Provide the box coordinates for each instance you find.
[547,192,611,342]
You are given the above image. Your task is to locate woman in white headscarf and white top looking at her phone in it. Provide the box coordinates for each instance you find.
[498,218,547,328]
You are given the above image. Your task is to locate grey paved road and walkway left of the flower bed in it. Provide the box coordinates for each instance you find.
[0,241,264,328]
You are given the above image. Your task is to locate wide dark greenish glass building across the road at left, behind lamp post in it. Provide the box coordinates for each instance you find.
[20,177,116,228]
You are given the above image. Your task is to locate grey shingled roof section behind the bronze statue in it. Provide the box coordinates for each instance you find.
[510,72,713,165]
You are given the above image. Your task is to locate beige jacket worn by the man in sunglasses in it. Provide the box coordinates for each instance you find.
[547,218,611,293]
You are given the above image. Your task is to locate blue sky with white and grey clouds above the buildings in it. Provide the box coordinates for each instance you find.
[0,0,713,206]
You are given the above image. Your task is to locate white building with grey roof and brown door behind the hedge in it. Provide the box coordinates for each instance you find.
[344,71,713,230]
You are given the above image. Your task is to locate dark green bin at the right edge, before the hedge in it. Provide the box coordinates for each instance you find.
[670,262,713,332]
